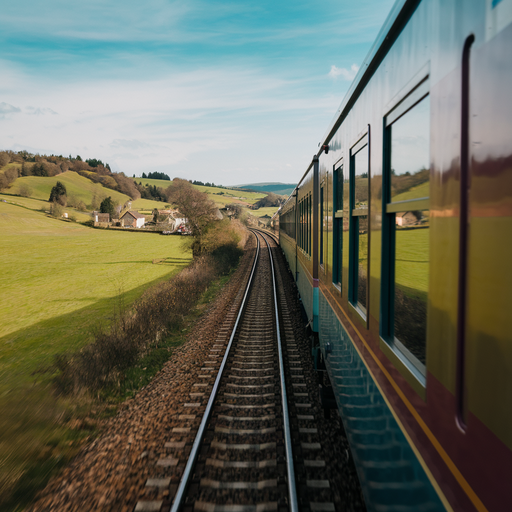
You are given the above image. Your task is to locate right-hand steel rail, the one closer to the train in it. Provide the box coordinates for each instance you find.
[263,231,299,512]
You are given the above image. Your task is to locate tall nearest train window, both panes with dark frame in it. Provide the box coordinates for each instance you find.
[381,88,430,385]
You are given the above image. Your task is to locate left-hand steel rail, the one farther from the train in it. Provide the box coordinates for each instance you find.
[170,236,260,512]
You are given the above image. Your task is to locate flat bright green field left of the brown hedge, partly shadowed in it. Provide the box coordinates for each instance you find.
[0,202,191,388]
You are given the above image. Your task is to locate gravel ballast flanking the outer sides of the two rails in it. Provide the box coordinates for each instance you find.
[28,233,364,512]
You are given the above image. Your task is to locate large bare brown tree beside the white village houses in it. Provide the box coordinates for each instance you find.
[165,178,217,256]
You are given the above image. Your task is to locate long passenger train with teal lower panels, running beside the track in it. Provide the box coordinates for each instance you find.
[271,0,512,512]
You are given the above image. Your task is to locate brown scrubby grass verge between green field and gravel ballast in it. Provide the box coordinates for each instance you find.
[0,248,241,512]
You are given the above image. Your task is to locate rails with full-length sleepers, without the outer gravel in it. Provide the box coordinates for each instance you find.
[135,231,344,512]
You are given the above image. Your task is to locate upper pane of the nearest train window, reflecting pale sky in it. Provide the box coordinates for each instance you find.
[390,96,430,202]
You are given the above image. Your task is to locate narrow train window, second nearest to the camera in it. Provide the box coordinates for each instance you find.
[349,135,369,317]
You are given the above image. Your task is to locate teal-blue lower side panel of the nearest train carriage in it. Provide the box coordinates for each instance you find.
[319,293,445,512]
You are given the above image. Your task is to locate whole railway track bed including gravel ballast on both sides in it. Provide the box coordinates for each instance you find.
[30,229,364,512]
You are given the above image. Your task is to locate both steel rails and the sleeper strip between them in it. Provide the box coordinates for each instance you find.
[171,232,297,512]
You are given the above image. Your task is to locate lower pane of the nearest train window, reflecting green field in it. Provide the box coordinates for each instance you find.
[393,211,429,374]
